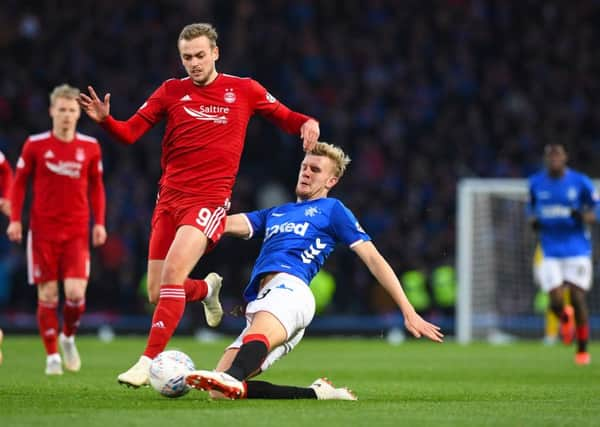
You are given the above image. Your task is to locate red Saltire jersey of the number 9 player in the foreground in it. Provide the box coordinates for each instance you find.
[137,74,310,203]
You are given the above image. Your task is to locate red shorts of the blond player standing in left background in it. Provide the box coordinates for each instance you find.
[27,231,90,284]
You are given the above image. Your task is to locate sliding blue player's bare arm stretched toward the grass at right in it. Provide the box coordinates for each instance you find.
[352,242,444,342]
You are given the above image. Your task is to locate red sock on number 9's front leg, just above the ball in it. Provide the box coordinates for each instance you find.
[144,285,185,359]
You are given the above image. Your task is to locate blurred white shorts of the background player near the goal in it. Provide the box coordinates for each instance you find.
[537,256,592,292]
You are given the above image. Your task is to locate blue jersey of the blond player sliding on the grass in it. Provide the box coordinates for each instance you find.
[244,198,371,302]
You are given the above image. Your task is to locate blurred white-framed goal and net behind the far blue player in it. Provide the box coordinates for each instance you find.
[456,179,600,343]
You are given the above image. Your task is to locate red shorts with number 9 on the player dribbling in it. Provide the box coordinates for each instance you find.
[148,188,229,260]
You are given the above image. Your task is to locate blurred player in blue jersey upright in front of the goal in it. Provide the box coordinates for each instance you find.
[528,144,599,365]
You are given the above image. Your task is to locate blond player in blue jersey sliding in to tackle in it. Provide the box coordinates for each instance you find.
[186,142,443,400]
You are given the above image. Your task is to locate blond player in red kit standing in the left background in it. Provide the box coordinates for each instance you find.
[7,84,106,375]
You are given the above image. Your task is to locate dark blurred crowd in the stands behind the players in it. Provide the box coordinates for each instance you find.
[0,0,600,313]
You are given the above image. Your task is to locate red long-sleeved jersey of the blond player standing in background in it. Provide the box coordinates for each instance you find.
[10,131,105,232]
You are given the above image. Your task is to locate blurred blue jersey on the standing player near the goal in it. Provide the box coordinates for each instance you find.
[528,169,598,258]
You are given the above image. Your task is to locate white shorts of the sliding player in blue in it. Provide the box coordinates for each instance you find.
[227,273,315,372]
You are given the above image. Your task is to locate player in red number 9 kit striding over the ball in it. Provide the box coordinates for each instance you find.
[80,23,319,387]
